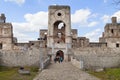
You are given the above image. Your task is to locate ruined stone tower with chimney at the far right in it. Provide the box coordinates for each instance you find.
[100,17,120,48]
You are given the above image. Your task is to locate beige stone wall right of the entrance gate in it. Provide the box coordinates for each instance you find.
[73,48,120,69]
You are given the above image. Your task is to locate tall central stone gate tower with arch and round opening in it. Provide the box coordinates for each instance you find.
[47,5,72,60]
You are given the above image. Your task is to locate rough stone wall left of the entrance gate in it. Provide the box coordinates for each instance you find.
[0,48,47,66]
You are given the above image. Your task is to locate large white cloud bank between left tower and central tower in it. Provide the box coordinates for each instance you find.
[12,12,48,41]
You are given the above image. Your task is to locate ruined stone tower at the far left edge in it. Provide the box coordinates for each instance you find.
[0,14,13,50]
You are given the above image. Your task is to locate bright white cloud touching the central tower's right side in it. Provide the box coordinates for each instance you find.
[71,9,98,27]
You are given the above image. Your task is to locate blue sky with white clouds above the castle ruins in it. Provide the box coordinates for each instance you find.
[0,0,120,42]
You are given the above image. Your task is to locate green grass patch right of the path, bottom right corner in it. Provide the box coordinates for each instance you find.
[89,68,120,80]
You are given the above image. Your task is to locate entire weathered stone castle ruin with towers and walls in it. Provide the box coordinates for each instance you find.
[0,5,120,68]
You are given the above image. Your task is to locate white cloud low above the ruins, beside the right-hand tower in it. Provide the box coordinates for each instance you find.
[84,29,101,42]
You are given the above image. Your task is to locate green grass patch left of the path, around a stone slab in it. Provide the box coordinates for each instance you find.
[0,66,38,80]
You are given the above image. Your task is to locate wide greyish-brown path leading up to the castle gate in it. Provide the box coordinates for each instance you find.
[34,62,100,80]
